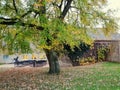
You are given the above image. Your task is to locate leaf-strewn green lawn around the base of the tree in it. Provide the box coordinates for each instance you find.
[0,62,120,90]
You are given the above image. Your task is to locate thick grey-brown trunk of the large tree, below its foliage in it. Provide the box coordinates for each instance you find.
[45,50,60,74]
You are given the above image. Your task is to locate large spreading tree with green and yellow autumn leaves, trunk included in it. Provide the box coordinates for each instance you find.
[0,0,117,73]
